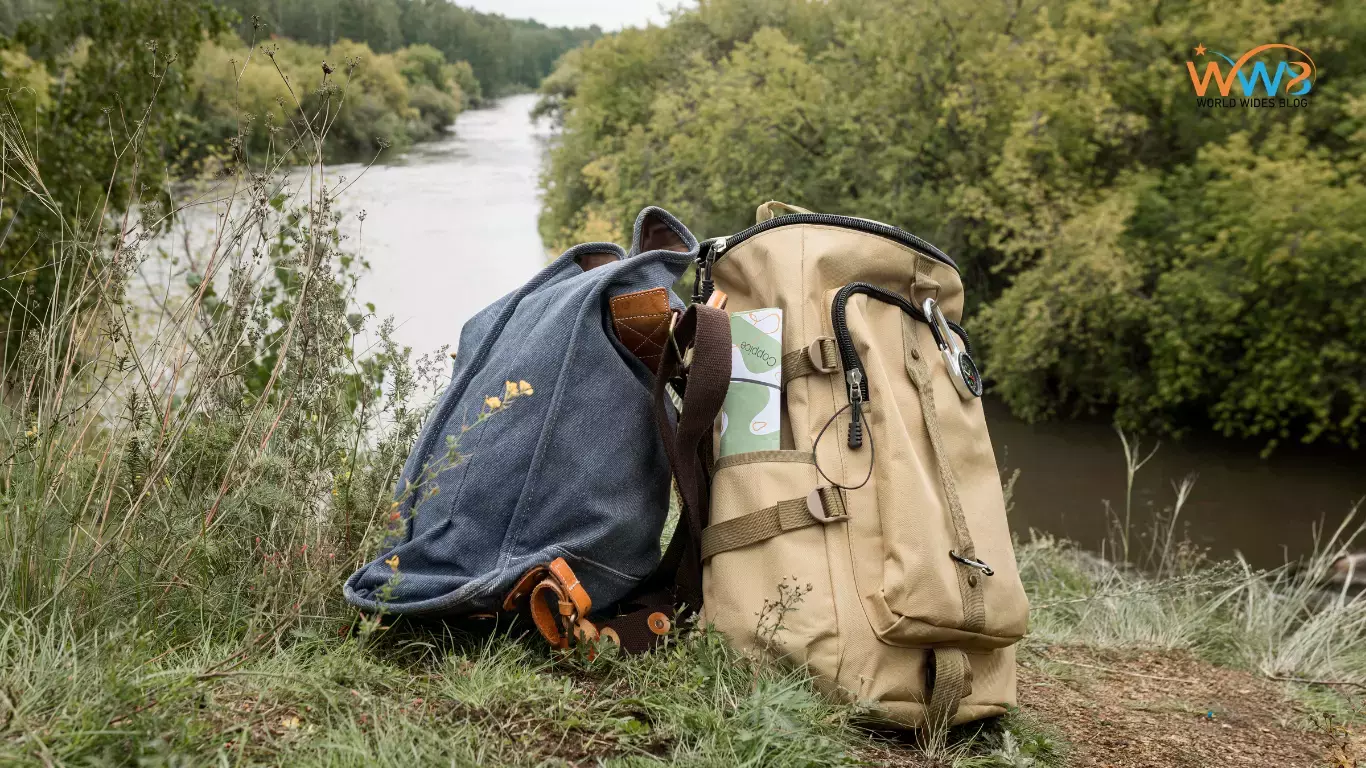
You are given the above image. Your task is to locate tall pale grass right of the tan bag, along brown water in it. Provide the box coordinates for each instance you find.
[1016,435,1366,694]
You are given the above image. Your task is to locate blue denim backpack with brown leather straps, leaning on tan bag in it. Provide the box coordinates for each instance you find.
[344,208,729,650]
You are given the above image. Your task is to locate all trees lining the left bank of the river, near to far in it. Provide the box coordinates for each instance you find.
[0,0,597,344]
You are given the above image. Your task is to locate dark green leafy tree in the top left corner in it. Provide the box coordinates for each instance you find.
[0,0,223,332]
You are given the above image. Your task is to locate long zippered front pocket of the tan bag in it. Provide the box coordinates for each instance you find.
[813,294,1027,650]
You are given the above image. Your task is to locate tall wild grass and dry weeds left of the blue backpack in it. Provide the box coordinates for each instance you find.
[0,32,440,644]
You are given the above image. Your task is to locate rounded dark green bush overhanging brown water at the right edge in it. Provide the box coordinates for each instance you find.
[981,126,1366,447]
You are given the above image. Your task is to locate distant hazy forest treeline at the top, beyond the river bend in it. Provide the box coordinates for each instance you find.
[213,0,601,96]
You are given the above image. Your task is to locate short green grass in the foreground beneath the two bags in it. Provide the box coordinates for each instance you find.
[0,609,1060,767]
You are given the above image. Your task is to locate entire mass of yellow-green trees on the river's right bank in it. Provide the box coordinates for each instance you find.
[542,0,1366,444]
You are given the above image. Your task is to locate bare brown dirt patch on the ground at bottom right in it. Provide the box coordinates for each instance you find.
[1019,646,1329,768]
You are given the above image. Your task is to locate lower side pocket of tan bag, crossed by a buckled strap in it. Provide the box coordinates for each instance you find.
[702,451,844,681]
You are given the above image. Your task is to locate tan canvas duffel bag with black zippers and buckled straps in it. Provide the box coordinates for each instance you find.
[694,202,1029,727]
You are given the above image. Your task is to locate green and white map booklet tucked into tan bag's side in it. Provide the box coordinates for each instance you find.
[717,307,783,458]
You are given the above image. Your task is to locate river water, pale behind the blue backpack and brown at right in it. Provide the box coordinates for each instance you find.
[335,96,1366,566]
